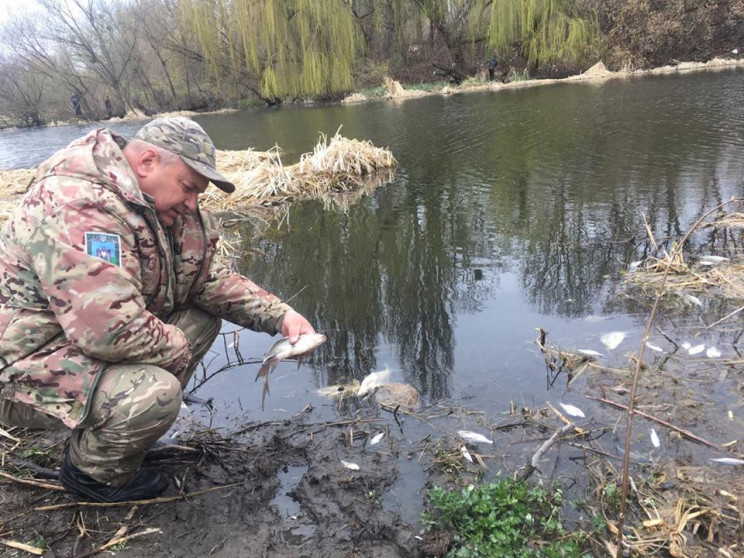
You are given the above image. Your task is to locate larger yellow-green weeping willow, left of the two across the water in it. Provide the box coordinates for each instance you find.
[181,0,362,101]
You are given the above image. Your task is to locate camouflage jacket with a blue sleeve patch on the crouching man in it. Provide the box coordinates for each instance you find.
[0,130,290,428]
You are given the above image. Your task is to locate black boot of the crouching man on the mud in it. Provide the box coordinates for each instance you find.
[59,452,168,502]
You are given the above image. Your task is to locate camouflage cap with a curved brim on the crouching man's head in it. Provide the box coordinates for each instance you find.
[135,116,235,193]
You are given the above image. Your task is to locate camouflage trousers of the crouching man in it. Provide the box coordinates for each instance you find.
[0,308,222,486]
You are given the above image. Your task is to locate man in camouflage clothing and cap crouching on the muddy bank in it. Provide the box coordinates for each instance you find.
[0,117,314,502]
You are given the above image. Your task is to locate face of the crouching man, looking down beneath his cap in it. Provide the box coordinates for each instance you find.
[140,158,209,226]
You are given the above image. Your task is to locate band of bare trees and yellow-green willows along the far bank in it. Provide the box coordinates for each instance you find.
[0,0,744,127]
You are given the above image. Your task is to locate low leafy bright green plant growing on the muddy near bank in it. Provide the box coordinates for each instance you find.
[422,479,582,558]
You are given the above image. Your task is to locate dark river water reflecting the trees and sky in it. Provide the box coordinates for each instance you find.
[0,70,744,419]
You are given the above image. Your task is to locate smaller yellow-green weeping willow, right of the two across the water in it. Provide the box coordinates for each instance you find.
[484,0,599,69]
